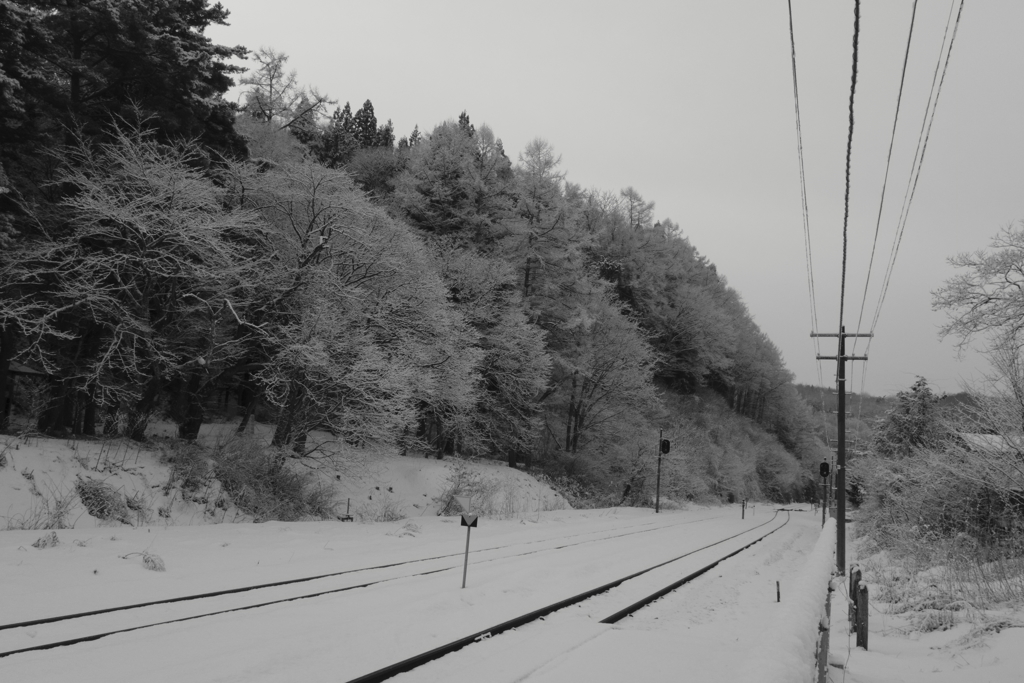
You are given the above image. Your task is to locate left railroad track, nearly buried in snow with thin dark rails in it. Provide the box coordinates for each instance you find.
[0,517,729,658]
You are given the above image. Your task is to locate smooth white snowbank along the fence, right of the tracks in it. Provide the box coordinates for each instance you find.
[736,519,836,683]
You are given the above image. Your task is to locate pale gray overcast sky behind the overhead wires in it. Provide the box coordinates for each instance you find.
[209,0,1024,394]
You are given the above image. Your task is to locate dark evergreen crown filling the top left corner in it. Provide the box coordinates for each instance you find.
[0,0,246,154]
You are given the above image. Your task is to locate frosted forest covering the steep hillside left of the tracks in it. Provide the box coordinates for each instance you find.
[0,0,827,504]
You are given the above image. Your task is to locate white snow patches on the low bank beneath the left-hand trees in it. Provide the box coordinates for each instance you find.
[0,422,568,529]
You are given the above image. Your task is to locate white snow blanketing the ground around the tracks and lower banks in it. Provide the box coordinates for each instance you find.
[0,438,1024,683]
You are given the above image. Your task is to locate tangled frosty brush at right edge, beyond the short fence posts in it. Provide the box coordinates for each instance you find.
[854,446,1024,611]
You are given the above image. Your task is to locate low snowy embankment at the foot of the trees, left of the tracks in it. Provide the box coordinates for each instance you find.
[0,423,567,529]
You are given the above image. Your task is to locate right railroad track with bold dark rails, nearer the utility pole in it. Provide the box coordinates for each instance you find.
[347,511,790,683]
